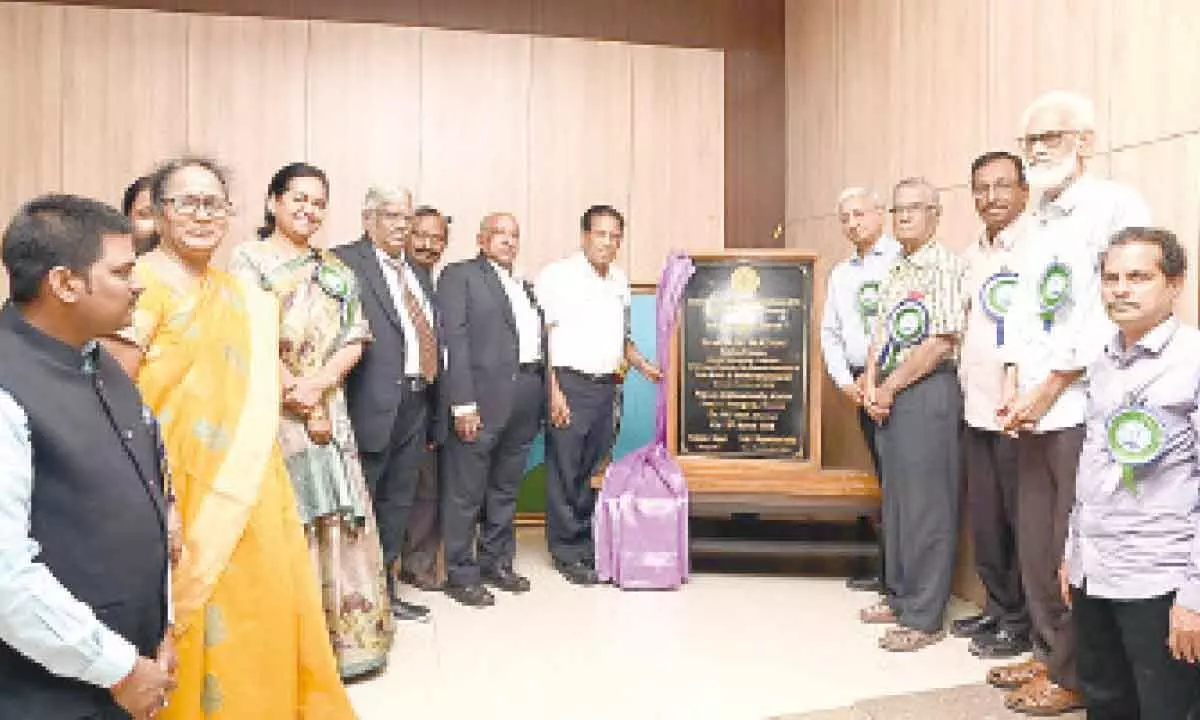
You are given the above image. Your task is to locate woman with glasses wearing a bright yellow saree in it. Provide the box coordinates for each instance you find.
[109,158,355,720]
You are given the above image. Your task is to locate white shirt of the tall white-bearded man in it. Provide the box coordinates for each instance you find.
[1002,175,1150,432]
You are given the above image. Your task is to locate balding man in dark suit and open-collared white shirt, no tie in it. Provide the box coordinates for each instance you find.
[438,214,546,607]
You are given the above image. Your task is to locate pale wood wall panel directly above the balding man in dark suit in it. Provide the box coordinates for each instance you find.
[416,30,540,274]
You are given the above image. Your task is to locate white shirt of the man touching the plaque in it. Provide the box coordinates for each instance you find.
[538,251,632,374]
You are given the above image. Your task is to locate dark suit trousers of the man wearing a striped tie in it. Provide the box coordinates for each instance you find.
[360,391,428,578]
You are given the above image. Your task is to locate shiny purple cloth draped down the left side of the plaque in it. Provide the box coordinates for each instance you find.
[593,251,695,589]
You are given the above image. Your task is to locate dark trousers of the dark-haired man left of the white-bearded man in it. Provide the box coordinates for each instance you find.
[961,426,1030,637]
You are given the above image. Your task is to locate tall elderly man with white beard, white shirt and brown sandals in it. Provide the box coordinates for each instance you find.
[988,92,1150,716]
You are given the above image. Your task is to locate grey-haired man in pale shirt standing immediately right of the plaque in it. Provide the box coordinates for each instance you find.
[821,187,900,593]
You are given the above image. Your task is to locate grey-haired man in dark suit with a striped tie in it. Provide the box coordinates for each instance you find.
[334,187,440,620]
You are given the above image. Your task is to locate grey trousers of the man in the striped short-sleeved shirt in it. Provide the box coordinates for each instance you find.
[876,364,962,632]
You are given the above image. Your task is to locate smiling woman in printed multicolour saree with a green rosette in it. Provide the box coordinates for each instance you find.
[229,163,392,679]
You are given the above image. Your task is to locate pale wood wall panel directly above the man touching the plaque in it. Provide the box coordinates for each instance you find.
[522,37,634,277]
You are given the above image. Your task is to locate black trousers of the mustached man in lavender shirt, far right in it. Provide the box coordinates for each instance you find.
[1070,588,1200,720]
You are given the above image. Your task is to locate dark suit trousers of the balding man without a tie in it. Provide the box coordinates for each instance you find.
[438,372,546,587]
